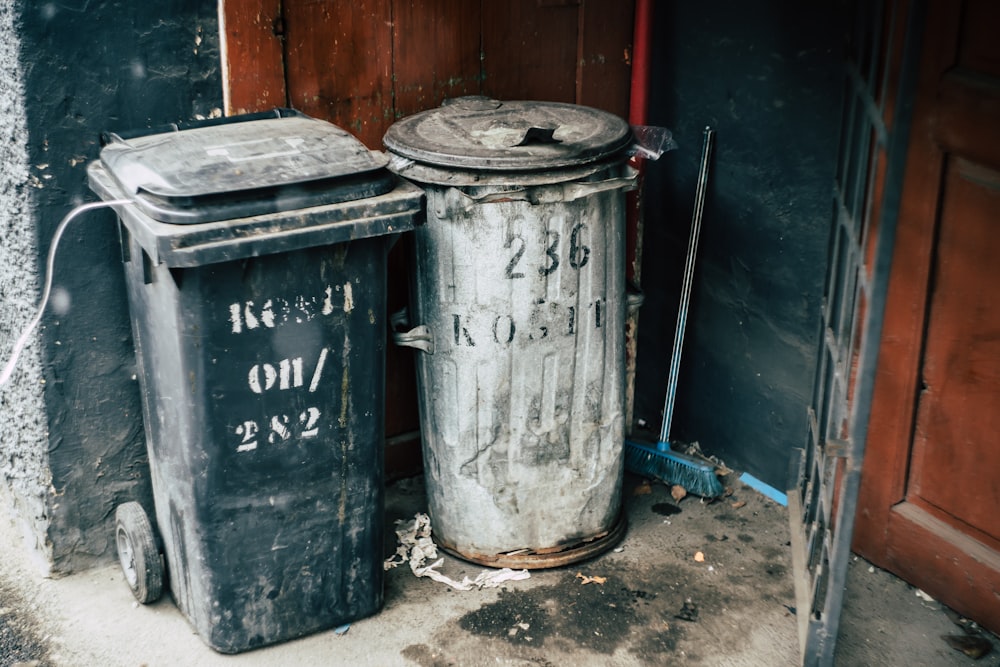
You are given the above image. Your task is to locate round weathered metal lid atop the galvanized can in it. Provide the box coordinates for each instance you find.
[383,97,632,171]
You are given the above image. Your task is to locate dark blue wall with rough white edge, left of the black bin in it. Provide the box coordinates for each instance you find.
[0,0,222,573]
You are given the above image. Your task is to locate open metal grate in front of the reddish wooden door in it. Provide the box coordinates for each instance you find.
[788,0,924,666]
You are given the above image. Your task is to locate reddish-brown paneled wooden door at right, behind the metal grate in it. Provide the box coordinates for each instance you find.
[854,0,1000,631]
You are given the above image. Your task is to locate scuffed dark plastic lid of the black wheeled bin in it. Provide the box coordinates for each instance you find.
[100,109,395,224]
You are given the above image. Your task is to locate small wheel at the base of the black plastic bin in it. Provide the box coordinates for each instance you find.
[115,502,163,604]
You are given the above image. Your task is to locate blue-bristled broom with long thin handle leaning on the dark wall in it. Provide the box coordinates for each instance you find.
[625,127,724,498]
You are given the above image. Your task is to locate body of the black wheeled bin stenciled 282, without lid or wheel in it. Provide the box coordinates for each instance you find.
[89,113,422,653]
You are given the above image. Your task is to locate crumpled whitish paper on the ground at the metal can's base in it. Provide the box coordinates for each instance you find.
[384,513,531,591]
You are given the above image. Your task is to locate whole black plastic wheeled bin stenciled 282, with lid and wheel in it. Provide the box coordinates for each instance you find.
[88,110,423,653]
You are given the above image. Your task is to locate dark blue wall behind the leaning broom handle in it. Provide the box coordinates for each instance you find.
[636,0,843,490]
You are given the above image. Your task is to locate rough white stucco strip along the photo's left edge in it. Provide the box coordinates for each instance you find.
[0,0,49,570]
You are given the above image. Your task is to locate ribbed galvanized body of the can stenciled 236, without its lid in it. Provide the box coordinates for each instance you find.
[398,164,634,566]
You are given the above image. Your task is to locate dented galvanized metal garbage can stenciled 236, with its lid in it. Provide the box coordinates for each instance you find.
[384,97,635,568]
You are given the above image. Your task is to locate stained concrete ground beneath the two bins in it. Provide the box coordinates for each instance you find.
[0,476,1000,667]
